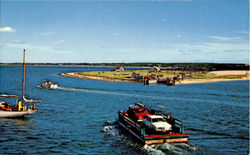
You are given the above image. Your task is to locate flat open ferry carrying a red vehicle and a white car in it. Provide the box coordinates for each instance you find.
[117,103,189,145]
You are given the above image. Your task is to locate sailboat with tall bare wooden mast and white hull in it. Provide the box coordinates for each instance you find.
[0,49,42,118]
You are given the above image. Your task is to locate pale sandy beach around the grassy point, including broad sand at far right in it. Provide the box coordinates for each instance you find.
[60,70,249,84]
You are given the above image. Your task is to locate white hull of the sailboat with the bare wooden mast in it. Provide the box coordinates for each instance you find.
[0,109,37,118]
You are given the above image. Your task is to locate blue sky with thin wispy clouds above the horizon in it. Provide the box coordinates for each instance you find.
[0,0,249,64]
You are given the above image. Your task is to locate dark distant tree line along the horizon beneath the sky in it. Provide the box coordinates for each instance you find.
[0,62,249,71]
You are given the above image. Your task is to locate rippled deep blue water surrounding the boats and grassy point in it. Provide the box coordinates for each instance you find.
[0,66,249,154]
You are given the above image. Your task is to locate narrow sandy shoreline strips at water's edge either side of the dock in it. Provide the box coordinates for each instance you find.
[59,72,250,85]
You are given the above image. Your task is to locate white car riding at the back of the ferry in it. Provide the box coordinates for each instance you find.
[144,115,172,132]
